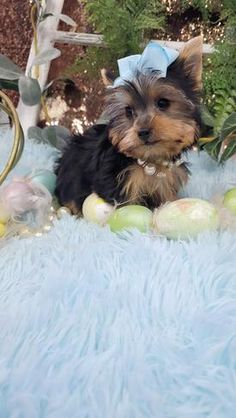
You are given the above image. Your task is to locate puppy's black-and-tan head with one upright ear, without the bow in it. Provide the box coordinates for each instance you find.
[103,37,202,161]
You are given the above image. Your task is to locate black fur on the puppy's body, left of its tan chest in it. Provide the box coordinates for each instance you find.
[56,125,132,208]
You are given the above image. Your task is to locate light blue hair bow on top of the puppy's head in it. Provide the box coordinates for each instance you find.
[113,41,179,87]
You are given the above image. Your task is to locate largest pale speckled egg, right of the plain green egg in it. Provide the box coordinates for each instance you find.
[153,198,219,239]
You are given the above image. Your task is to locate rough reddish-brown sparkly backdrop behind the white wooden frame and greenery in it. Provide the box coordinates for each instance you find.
[0,0,222,131]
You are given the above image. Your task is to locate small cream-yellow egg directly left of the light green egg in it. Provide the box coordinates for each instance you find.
[82,193,114,225]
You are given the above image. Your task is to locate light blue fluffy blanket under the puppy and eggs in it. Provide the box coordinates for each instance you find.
[0,129,236,418]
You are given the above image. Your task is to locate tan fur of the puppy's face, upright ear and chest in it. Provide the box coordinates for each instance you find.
[106,36,203,205]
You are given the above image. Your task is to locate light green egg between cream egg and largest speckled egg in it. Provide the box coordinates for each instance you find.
[108,205,152,232]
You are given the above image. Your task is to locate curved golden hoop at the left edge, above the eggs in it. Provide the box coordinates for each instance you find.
[0,91,24,184]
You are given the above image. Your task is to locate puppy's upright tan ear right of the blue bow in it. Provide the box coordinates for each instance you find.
[178,35,203,90]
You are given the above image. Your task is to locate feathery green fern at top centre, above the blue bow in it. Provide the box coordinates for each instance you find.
[74,0,165,76]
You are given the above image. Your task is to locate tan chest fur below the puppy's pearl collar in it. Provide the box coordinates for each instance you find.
[119,163,187,205]
